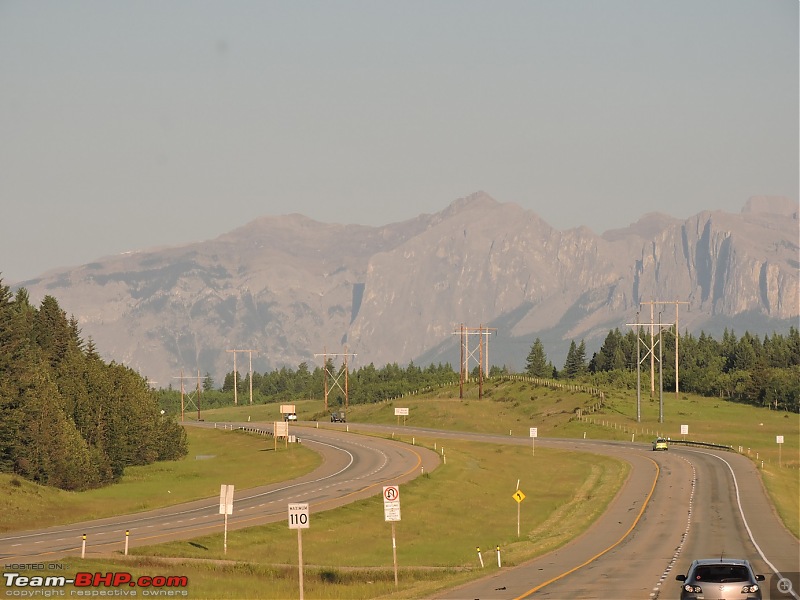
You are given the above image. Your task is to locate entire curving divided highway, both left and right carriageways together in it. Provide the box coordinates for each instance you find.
[0,424,800,600]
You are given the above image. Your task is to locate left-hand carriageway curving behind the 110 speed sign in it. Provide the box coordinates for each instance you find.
[0,423,439,564]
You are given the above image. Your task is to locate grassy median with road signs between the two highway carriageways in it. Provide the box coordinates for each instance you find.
[71,436,627,599]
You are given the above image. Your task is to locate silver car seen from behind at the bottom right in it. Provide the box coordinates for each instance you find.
[675,558,764,600]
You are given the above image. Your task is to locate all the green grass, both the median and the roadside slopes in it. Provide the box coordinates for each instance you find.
[0,380,800,599]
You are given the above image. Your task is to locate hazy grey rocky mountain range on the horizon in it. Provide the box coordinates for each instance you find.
[15,192,800,387]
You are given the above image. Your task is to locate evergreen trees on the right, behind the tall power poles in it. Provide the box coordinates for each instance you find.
[526,327,800,412]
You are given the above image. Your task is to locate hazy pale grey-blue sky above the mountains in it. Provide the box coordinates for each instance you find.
[0,0,800,283]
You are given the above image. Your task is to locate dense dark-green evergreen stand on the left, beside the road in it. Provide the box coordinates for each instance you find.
[0,279,188,490]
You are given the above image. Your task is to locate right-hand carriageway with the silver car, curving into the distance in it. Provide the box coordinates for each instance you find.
[340,426,800,600]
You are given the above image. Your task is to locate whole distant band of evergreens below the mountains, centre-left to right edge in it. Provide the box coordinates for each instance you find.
[186,327,800,412]
